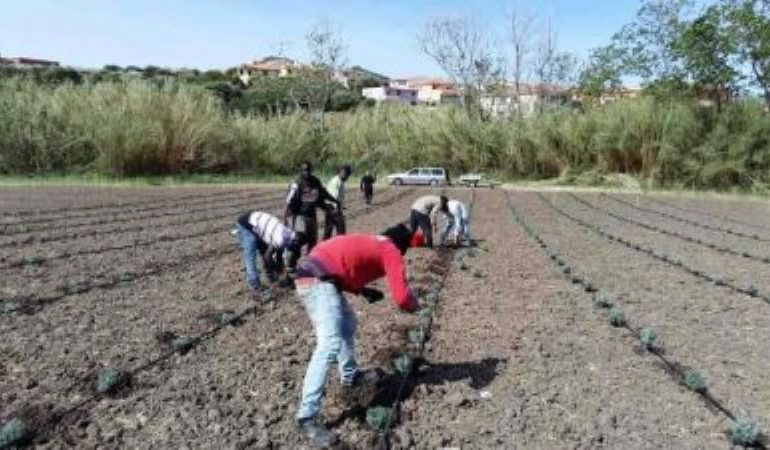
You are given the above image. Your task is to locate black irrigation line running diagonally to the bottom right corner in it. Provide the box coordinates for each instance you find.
[506,193,764,448]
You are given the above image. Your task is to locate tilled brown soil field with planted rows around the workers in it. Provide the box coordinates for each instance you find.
[0,187,770,449]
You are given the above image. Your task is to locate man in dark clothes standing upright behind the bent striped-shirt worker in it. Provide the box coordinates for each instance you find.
[283,161,339,270]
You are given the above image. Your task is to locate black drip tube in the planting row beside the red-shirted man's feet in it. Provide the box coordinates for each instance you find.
[375,190,476,450]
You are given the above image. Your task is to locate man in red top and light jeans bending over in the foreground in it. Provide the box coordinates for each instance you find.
[295,224,420,447]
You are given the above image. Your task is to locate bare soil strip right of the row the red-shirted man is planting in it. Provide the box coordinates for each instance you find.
[396,192,726,448]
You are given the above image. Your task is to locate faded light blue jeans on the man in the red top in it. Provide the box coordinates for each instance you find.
[297,282,358,420]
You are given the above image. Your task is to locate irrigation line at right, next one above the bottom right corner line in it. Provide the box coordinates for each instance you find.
[537,192,770,305]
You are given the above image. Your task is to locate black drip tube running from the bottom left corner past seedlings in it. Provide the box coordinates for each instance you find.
[0,189,412,449]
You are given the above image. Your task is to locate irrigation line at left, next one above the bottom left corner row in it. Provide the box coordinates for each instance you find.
[0,190,411,315]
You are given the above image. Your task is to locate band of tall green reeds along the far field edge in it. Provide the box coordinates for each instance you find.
[0,79,770,193]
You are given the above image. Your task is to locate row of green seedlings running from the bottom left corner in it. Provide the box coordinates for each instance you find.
[0,191,410,450]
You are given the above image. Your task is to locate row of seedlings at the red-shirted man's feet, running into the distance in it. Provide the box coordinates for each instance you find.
[366,191,476,450]
